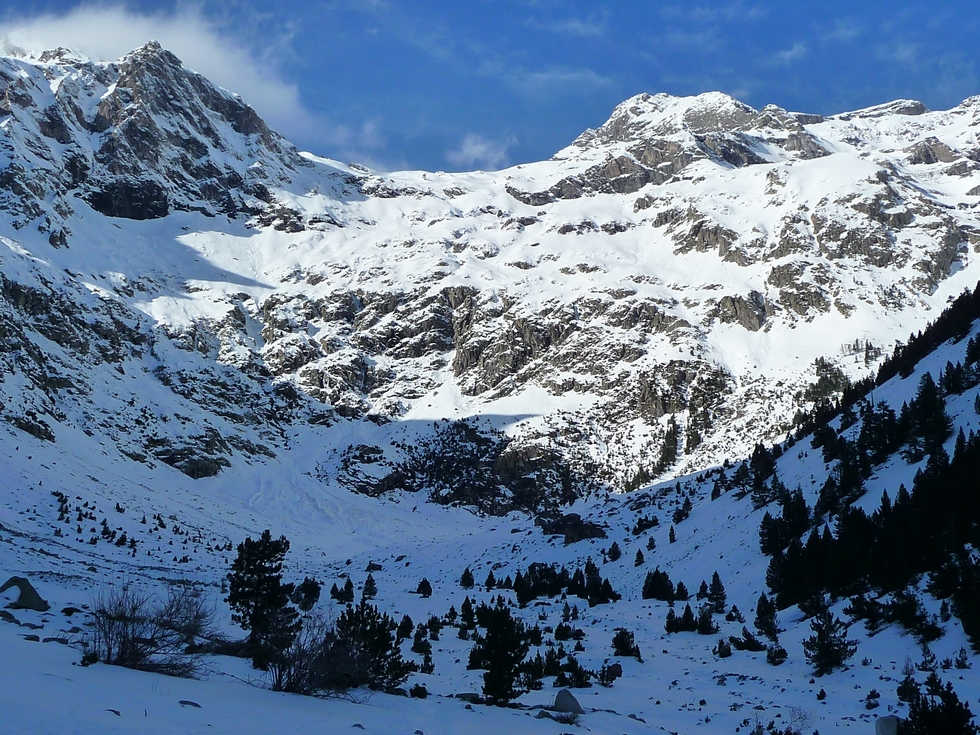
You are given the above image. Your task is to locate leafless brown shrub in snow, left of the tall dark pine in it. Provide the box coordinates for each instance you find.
[83,583,214,677]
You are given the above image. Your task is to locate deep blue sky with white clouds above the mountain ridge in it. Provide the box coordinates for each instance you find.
[0,0,980,170]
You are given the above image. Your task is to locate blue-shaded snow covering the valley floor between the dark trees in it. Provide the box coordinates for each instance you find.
[0,312,980,733]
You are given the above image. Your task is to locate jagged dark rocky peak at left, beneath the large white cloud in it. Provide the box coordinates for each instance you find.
[0,42,309,239]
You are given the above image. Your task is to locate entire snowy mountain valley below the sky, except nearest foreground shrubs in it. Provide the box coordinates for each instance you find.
[0,42,980,735]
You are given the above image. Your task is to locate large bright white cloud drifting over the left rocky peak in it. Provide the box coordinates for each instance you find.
[0,5,321,144]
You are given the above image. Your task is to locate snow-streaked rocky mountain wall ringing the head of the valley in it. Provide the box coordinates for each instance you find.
[0,43,980,510]
